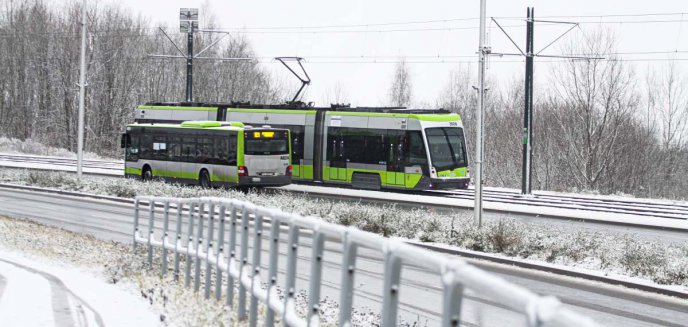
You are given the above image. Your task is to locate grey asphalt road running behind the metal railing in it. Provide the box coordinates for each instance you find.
[0,188,688,326]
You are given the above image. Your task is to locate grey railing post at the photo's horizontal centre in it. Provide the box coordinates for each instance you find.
[339,231,358,326]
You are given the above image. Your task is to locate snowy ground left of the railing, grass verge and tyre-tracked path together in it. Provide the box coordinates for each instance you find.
[0,217,238,327]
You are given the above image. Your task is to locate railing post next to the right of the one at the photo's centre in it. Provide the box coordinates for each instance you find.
[382,250,401,326]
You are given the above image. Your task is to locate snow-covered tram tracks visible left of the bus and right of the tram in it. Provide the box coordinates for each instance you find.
[0,154,688,223]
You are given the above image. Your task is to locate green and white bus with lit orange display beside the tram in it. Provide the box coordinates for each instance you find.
[122,121,292,188]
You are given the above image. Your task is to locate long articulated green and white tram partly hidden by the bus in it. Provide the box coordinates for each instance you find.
[136,103,470,190]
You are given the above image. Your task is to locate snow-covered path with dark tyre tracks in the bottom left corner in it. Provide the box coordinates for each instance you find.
[0,249,159,327]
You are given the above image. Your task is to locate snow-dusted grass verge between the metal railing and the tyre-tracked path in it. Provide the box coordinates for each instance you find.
[0,217,231,326]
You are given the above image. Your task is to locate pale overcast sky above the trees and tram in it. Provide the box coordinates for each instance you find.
[87,0,688,106]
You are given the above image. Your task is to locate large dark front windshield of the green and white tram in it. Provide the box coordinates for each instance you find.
[425,127,467,171]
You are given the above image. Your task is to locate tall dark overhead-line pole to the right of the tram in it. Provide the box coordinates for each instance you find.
[521,7,535,194]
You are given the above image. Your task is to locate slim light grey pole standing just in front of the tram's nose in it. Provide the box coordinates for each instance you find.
[474,0,490,227]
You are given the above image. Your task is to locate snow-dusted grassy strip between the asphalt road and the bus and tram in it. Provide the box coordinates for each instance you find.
[0,169,688,289]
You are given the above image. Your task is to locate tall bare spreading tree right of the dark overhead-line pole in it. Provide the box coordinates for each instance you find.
[551,30,638,189]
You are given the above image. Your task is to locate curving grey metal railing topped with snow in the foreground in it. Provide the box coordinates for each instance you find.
[133,197,597,327]
